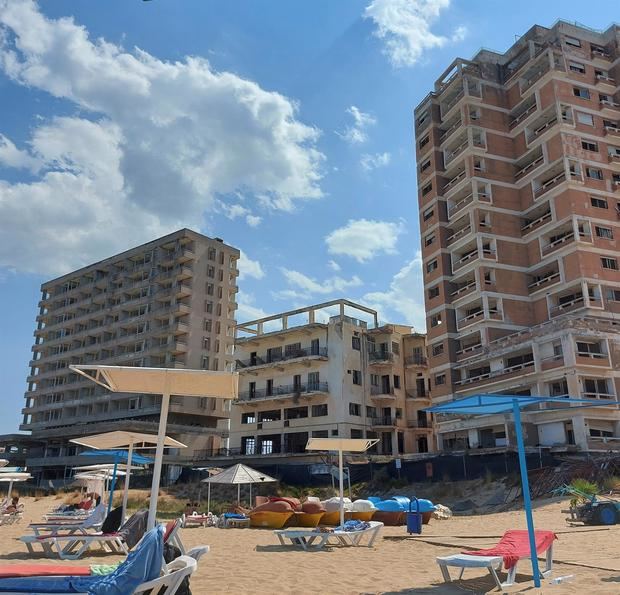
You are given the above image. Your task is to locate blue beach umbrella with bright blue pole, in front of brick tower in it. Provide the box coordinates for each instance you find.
[425,394,618,587]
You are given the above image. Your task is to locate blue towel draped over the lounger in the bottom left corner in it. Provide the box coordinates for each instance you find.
[0,525,164,595]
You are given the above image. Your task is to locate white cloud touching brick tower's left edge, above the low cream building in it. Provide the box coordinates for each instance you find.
[362,252,426,332]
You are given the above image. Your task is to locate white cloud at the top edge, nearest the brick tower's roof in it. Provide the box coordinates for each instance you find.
[364,0,467,67]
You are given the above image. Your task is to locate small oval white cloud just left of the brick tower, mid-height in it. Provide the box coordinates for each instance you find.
[325,219,405,262]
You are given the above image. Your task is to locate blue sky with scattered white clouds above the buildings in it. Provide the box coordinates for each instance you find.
[0,0,615,432]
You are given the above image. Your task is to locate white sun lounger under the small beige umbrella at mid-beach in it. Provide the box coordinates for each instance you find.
[274,521,383,551]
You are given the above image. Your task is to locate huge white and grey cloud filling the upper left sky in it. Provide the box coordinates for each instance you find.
[0,0,324,274]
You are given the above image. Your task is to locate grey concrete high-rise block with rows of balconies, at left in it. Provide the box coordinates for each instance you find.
[20,229,239,480]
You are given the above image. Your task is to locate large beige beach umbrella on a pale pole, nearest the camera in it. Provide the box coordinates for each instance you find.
[70,365,239,530]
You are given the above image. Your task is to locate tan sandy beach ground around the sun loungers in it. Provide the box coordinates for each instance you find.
[0,498,620,595]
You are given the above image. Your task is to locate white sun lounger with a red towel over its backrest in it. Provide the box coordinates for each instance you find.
[437,530,557,590]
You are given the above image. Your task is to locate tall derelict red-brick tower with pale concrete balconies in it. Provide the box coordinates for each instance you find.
[415,22,620,450]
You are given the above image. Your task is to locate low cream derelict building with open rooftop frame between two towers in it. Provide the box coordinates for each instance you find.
[225,300,434,457]
